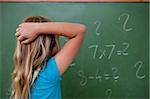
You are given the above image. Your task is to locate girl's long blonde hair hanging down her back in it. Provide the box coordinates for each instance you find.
[10,16,59,99]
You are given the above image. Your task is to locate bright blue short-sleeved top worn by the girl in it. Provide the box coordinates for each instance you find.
[29,57,62,99]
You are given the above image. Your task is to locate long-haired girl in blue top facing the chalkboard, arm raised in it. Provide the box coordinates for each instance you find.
[11,16,86,99]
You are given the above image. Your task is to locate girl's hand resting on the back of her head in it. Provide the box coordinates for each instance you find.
[15,22,39,44]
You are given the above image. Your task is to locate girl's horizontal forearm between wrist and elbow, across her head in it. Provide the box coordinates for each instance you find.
[38,22,86,38]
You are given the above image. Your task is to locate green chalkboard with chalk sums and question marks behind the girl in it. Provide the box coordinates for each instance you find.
[0,2,149,99]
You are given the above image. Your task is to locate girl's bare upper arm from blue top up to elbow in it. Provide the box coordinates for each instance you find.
[55,28,86,75]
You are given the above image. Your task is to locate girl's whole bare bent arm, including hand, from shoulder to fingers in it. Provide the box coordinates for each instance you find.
[15,22,86,75]
